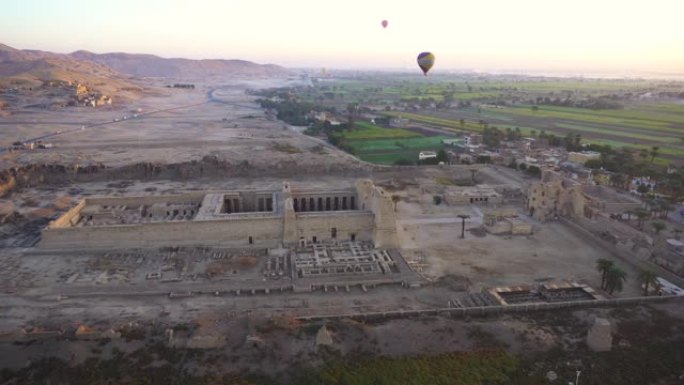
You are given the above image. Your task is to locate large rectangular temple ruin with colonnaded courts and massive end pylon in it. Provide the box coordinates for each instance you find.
[39,180,398,249]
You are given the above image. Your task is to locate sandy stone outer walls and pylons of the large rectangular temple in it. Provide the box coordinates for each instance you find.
[38,180,398,249]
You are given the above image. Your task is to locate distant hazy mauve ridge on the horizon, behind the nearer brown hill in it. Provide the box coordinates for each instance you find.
[70,51,287,78]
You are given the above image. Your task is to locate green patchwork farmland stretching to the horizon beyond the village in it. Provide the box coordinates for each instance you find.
[306,73,684,163]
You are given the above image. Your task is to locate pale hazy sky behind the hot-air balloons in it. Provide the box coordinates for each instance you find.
[0,0,684,73]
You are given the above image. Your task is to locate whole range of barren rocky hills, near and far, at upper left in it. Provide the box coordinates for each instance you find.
[0,44,288,110]
